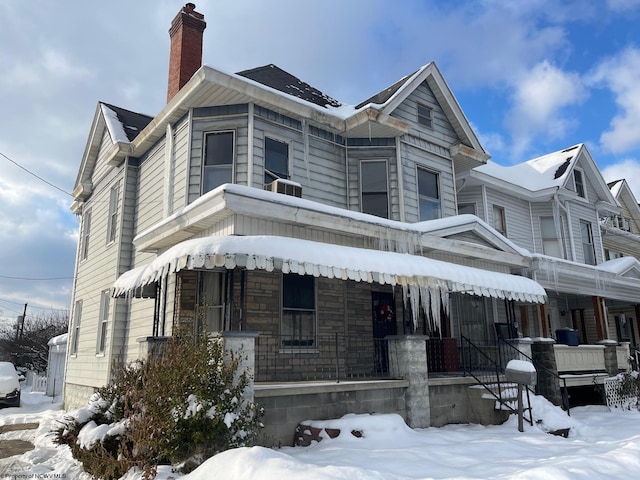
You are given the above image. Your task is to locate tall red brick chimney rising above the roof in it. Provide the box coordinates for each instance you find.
[167,3,207,103]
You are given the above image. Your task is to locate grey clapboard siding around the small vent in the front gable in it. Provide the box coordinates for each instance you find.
[391,81,460,146]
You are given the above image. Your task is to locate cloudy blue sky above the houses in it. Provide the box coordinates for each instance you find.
[0,0,640,326]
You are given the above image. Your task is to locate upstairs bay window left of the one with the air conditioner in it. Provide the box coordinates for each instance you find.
[202,132,234,193]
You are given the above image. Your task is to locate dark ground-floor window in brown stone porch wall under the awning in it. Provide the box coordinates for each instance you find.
[281,273,316,347]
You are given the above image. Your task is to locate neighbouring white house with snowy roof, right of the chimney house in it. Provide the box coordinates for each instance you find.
[457,144,640,398]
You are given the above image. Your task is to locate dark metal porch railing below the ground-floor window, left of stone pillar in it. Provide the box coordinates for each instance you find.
[254,333,396,382]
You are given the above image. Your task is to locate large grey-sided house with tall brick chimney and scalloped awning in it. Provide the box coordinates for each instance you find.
[64,3,556,441]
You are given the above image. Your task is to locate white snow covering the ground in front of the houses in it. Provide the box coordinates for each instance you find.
[0,392,640,480]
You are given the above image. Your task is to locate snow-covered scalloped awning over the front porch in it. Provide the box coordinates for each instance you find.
[113,236,546,303]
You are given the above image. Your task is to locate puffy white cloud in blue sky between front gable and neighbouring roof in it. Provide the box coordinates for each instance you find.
[507,60,587,153]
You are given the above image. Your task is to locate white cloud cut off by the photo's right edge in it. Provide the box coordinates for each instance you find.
[590,47,640,153]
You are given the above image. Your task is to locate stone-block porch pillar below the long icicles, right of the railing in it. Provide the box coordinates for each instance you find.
[385,335,431,428]
